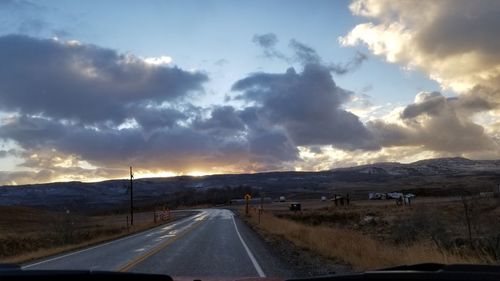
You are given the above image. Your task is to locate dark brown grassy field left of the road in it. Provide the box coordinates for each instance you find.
[0,206,181,263]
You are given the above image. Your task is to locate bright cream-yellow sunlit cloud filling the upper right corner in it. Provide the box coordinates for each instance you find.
[340,0,500,94]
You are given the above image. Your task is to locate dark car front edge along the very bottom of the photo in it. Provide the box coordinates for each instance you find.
[0,263,500,281]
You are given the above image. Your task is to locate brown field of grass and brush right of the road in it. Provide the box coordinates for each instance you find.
[240,197,500,271]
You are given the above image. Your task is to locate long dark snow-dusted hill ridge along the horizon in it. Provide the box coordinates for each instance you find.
[0,155,500,210]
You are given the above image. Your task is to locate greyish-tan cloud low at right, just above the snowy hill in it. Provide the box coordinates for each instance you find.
[368,92,500,155]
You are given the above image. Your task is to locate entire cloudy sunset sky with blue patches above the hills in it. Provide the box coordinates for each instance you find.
[0,0,500,185]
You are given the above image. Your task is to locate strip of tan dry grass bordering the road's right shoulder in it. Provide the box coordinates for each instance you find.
[242,207,490,270]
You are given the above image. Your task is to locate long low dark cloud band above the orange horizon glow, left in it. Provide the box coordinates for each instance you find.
[0,114,297,172]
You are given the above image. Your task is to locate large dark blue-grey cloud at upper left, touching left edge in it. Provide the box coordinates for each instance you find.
[0,36,208,123]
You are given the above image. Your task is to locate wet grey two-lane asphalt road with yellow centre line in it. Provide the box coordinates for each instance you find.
[23,209,290,277]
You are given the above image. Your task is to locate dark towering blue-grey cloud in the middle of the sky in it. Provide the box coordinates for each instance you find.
[232,64,378,149]
